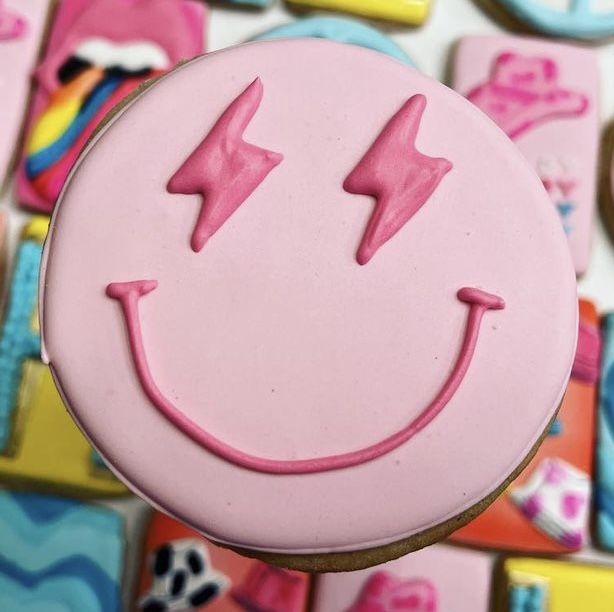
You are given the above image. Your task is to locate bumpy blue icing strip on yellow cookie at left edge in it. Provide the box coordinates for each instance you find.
[0,240,42,453]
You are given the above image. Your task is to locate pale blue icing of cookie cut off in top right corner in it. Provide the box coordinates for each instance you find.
[499,0,614,39]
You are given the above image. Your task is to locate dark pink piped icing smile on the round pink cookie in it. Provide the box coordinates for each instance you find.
[106,280,505,474]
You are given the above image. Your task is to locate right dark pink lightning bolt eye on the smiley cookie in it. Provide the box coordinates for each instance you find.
[343,94,452,265]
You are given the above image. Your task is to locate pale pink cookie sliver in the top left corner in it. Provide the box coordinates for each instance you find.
[0,0,50,186]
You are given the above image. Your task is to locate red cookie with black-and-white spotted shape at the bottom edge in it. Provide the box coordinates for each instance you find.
[137,512,309,612]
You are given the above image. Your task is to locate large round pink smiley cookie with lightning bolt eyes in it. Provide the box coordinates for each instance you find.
[41,39,577,569]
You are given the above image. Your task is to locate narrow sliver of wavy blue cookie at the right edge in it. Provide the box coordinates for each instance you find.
[595,314,614,550]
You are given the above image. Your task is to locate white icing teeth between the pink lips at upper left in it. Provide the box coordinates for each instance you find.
[75,38,170,72]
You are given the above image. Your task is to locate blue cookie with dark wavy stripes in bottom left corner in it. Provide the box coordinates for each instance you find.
[0,491,123,612]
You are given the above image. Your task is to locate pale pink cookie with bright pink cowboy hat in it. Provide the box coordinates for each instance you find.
[453,36,599,274]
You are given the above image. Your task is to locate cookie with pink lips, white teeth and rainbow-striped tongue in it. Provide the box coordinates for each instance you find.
[16,0,205,212]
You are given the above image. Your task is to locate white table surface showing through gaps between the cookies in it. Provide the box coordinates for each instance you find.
[0,0,614,609]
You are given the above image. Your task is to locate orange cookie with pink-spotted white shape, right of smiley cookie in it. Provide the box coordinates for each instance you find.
[451,300,600,553]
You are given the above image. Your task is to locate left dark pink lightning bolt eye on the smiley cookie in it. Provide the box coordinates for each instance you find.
[167,78,283,252]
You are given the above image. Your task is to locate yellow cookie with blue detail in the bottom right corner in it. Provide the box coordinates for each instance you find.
[497,558,614,612]
